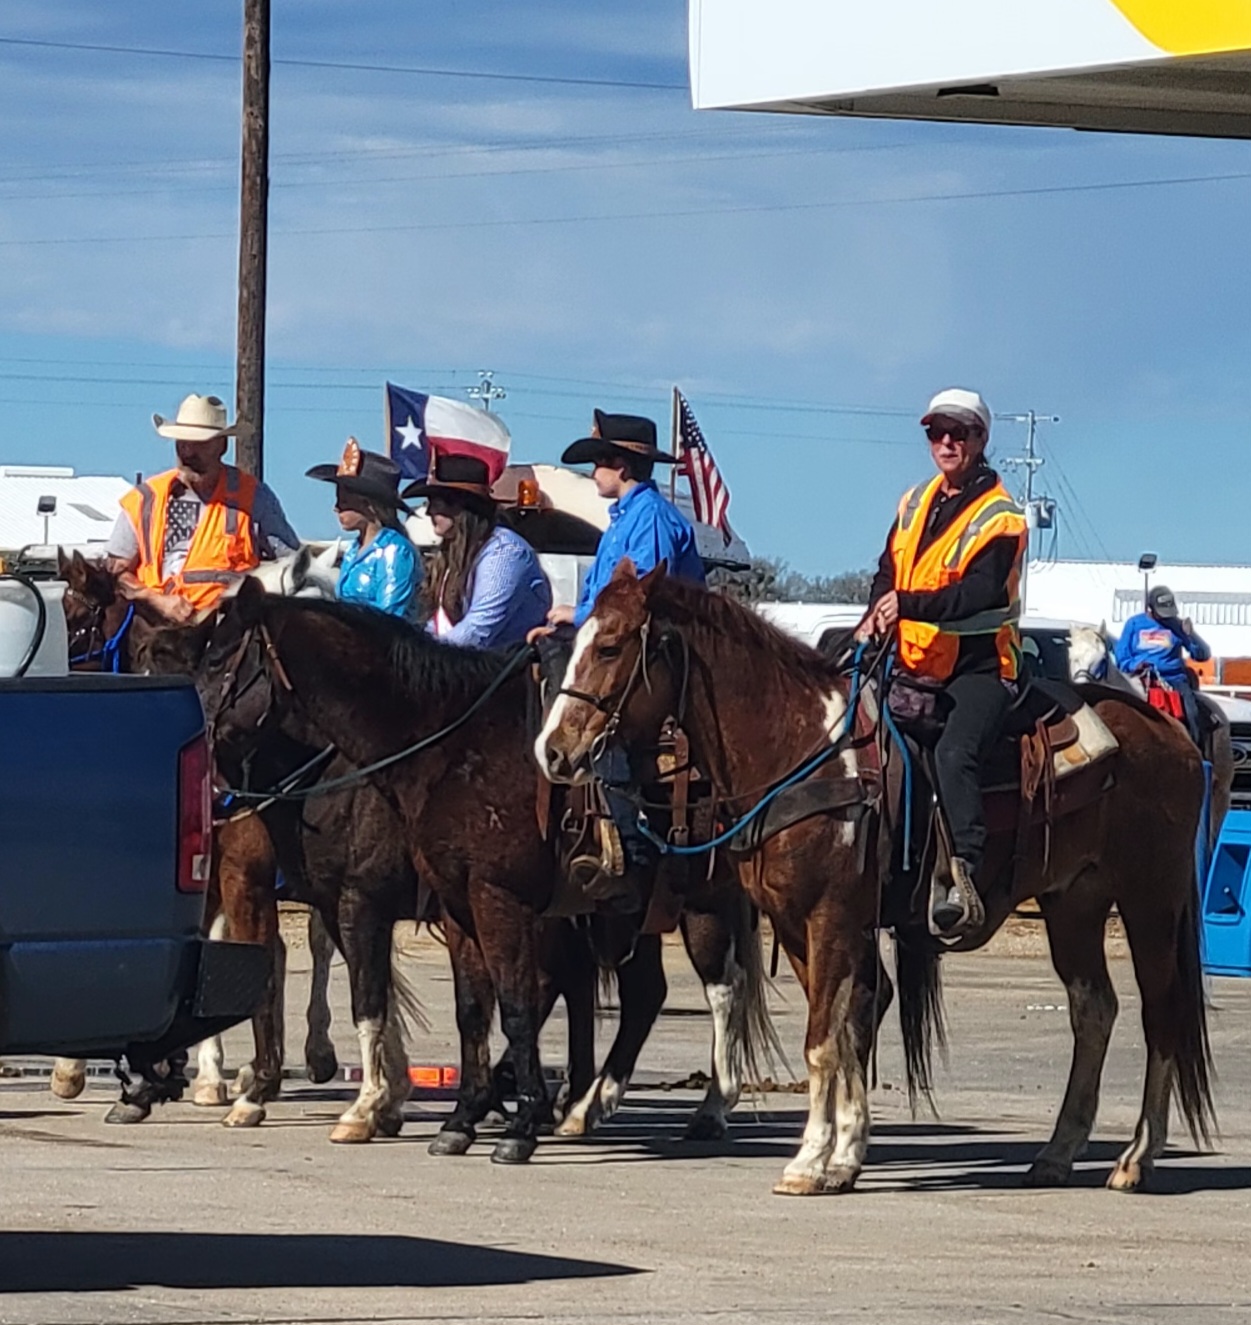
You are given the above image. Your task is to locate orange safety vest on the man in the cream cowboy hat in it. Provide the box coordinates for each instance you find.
[122,465,260,610]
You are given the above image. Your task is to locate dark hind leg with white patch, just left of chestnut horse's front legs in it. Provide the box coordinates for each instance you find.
[681,897,747,1141]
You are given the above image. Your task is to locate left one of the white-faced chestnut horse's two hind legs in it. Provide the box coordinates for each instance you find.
[1024,876,1117,1187]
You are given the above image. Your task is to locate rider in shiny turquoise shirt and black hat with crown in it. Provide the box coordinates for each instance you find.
[307,437,421,621]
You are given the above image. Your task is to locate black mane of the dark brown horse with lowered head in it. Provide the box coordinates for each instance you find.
[264,595,510,704]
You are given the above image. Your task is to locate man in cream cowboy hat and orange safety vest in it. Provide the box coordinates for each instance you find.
[105,395,299,621]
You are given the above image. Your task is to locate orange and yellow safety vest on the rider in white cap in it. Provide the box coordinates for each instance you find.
[891,474,1027,681]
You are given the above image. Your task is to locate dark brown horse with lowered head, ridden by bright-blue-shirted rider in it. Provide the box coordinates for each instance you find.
[200,584,779,1162]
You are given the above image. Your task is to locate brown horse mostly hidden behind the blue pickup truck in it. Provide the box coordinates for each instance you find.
[52,551,338,1126]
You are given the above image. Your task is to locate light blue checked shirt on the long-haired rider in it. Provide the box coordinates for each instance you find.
[425,525,551,649]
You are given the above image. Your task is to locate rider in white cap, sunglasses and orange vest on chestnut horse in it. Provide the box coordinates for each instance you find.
[857,387,1026,938]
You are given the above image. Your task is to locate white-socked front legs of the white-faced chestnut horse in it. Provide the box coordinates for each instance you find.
[773,901,879,1196]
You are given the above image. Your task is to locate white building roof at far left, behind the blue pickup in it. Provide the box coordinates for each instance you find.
[0,465,131,551]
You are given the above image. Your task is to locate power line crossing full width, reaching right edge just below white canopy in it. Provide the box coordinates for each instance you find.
[0,171,1251,248]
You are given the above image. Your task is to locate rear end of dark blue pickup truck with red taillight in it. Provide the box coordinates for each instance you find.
[0,585,268,1071]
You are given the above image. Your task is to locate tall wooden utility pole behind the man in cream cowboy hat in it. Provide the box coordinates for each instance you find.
[235,0,269,478]
